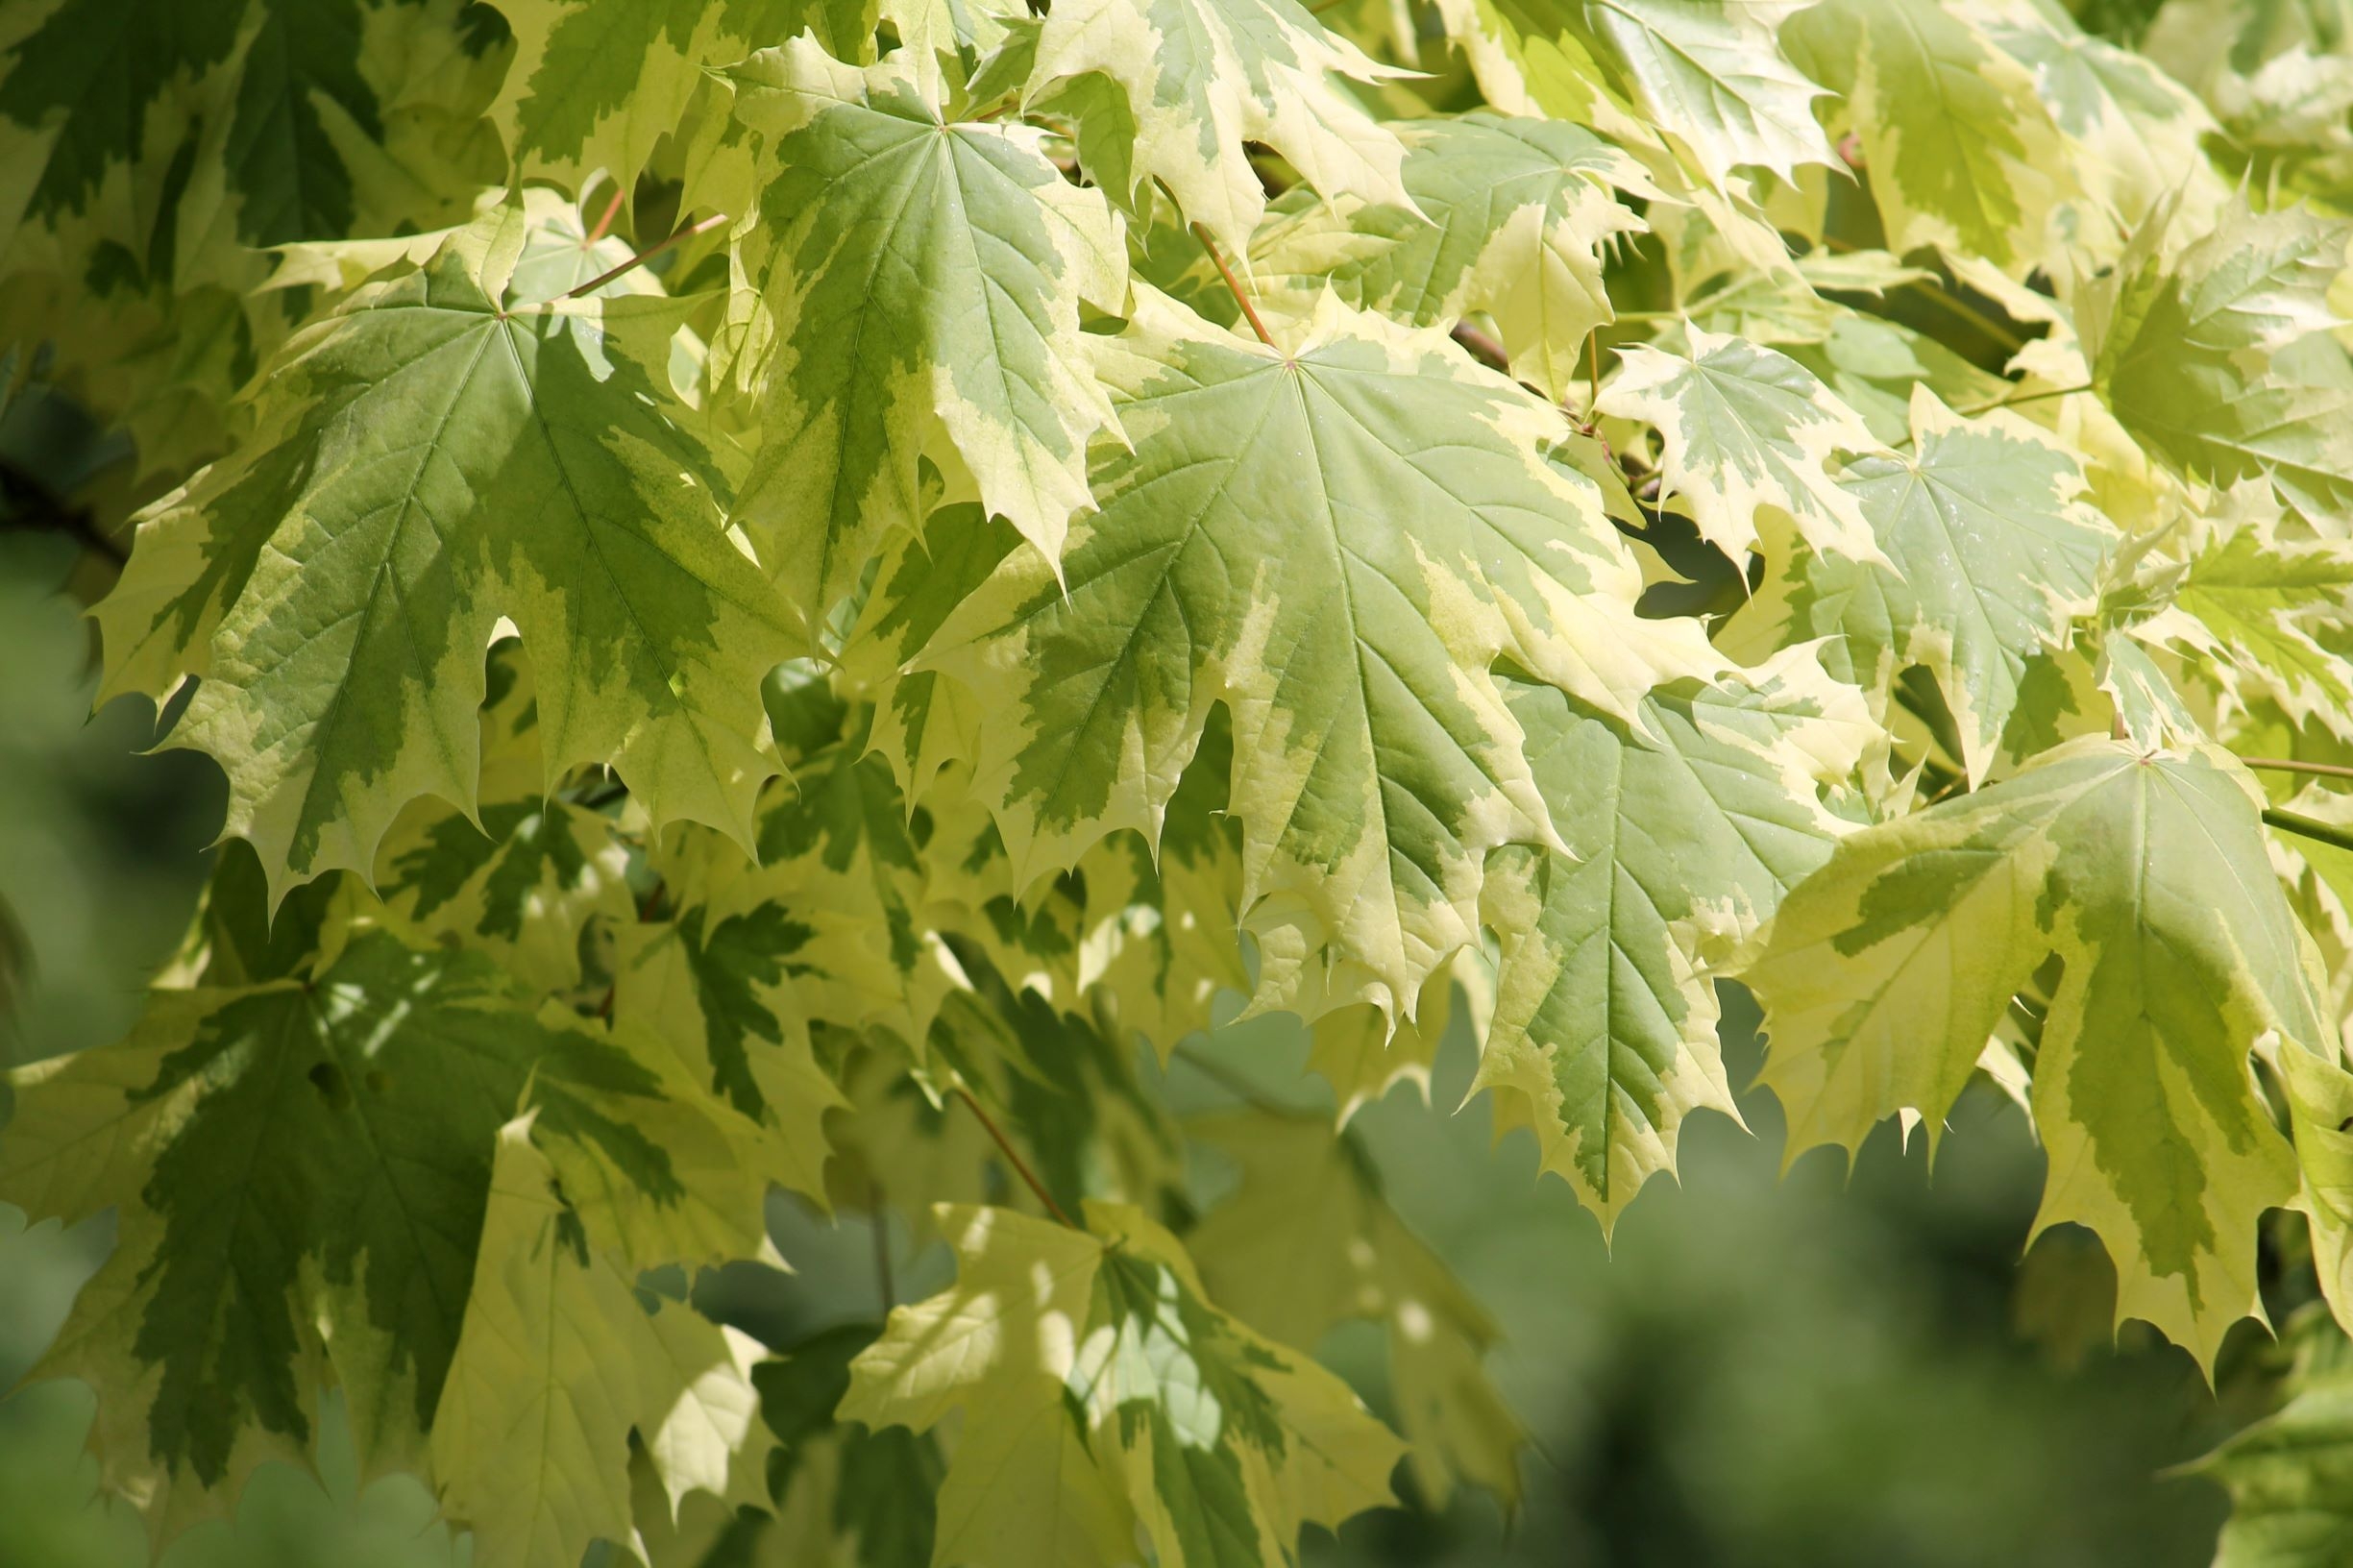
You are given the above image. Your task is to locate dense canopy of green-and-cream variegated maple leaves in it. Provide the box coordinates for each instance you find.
[0,0,2353,1568]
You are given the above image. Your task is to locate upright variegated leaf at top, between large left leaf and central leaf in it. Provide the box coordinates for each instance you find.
[729,37,1127,617]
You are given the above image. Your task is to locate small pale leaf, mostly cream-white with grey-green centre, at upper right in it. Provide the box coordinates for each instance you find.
[1600,328,1885,563]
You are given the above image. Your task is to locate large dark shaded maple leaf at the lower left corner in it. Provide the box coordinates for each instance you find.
[0,932,758,1531]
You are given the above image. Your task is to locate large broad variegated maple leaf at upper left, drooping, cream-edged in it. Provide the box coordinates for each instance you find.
[99,214,791,894]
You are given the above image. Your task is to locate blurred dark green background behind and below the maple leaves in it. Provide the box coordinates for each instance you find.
[0,372,2240,1568]
